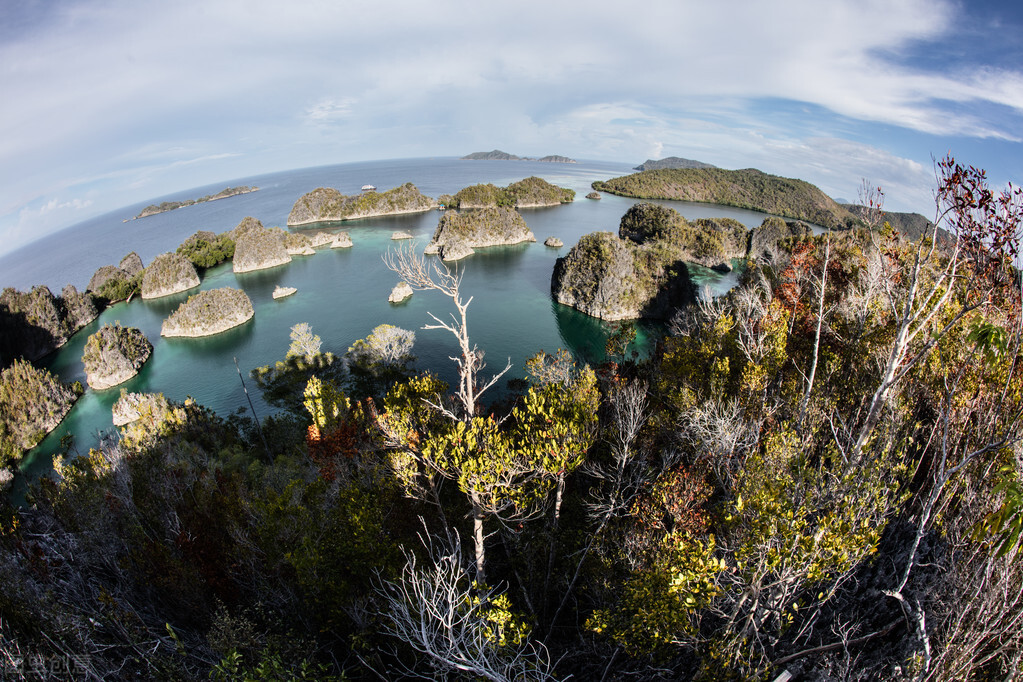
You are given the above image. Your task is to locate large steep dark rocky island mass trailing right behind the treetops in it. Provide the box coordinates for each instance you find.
[550,203,811,320]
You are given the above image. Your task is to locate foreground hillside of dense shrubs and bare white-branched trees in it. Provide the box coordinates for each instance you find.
[0,157,1023,682]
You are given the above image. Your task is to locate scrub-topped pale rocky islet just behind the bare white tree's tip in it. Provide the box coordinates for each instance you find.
[425,207,536,261]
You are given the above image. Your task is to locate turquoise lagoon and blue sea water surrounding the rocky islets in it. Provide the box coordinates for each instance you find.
[0,158,781,486]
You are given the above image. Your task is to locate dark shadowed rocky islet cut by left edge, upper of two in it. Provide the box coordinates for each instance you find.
[0,284,98,366]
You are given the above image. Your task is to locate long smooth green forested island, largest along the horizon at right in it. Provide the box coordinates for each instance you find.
[593,168,858,229]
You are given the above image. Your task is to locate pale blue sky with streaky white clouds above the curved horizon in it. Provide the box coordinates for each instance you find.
[0,0,1023,253]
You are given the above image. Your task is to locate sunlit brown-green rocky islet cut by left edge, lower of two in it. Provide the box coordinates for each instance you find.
[0,360,81,466]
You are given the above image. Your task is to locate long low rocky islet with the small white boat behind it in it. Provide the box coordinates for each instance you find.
[287,182,437,227]
